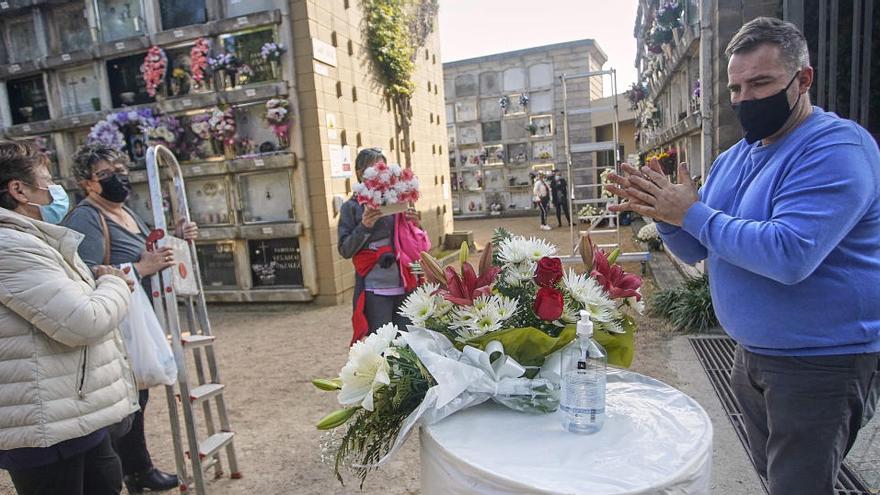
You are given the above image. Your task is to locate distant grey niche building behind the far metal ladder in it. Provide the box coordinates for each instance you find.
[443,39,607,217]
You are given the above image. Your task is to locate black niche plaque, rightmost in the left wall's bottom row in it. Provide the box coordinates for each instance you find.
[248,237,303,287]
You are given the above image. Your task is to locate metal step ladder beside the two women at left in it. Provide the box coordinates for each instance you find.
[146,146,241,495]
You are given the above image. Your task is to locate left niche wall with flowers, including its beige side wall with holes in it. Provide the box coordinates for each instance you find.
[0,0,452,303]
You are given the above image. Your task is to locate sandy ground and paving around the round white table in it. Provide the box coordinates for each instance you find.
[0,218,876,495]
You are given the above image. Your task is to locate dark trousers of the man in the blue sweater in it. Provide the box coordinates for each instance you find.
[731,347,880,495]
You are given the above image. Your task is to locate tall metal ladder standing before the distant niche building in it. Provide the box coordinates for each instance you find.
[559,69,650,262]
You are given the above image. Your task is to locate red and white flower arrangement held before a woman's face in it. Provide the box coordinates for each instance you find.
[354,162,419,208]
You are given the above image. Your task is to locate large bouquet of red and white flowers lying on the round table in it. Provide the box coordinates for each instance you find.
[314,229,642,484]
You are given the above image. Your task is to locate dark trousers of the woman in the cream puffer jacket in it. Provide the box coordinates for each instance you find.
[9,435,122,495]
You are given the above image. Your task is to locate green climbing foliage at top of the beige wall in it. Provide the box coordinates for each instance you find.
[364,0,417,98]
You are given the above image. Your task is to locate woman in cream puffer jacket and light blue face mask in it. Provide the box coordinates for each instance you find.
[0,141,138,494]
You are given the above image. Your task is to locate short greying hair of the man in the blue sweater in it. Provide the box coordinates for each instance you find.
[724,17,810,71]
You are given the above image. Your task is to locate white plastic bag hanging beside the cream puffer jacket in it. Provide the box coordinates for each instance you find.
[119,283,177,390]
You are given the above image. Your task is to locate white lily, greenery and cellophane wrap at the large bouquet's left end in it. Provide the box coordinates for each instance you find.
[313,323,559,486]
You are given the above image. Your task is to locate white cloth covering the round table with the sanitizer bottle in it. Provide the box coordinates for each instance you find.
[421,370,712,495]
